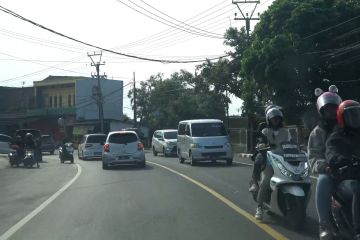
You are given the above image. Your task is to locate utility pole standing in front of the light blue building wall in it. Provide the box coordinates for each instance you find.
[88,52,105,133]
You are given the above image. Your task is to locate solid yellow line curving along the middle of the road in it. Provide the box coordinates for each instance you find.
[147,161,288,240]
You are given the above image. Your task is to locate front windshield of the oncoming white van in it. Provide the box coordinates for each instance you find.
[191,123,227,137]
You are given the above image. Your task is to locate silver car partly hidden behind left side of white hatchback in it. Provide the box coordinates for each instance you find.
[78,133,107,160]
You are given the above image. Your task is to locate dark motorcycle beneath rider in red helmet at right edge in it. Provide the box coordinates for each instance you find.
[331,156,360,239]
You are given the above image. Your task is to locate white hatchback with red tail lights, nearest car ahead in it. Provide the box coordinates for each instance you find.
[102,131,146,169]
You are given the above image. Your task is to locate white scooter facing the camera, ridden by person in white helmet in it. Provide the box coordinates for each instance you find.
[252,142,311,229]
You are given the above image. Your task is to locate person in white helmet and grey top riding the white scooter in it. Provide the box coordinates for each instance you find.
[249,106,291,220]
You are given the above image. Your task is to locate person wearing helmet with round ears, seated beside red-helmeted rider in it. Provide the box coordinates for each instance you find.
[308,86,341,239]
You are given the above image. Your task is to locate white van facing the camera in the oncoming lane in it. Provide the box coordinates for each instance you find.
[177,119,233,165]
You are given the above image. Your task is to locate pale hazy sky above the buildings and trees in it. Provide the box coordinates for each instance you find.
[0,0,272,116]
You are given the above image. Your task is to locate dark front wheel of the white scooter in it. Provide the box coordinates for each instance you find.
[286,196,306,230]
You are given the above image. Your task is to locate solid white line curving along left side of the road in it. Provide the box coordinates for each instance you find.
[0,164,82,240]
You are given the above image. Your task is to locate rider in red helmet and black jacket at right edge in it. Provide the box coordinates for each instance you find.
[325,100,360,240]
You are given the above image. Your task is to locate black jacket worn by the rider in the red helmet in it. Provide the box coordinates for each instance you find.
[325,129,360,178]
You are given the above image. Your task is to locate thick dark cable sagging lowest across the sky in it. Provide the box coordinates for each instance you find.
[0,6,228,63]
